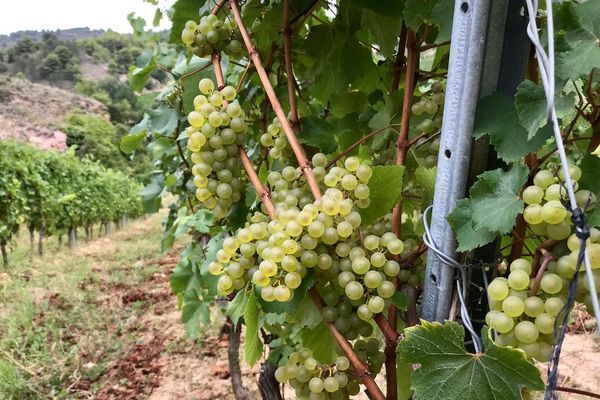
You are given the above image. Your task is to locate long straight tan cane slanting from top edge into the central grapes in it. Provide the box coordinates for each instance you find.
[229,0,322,200]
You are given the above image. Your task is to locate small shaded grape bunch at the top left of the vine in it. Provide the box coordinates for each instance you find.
[181,14,243,58]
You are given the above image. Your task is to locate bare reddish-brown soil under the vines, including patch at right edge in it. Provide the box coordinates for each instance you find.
[0,216,600,400]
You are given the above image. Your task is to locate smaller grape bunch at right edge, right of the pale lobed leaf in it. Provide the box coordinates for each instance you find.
[522,165,596,240]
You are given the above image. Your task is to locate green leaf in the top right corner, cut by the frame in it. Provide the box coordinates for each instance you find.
[555,1,600,79]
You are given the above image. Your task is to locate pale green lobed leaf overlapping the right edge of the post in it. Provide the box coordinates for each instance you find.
[448,165,528,251]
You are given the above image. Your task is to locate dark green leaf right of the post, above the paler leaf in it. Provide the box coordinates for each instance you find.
[473,92,552,162]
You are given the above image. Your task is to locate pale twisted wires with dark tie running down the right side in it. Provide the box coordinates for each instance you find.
[525,0,600,400]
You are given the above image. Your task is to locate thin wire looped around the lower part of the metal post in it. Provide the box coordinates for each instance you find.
[423,206,483,353]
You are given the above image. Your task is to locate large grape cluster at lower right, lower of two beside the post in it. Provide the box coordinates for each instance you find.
[485,258,568,362]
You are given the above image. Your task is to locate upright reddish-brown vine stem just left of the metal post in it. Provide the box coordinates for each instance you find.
[385,29,419,400]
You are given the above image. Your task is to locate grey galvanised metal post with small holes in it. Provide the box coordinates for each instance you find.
[420,0,491,321]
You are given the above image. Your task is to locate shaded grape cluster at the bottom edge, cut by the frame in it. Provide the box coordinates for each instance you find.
[275,348,360,400]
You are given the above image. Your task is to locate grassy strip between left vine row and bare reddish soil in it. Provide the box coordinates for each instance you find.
[0,215,162,400]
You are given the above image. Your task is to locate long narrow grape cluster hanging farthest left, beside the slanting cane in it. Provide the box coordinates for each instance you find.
[185,78,248,219]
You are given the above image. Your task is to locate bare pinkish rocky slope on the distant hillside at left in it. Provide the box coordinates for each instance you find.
[0,78,109,150]
